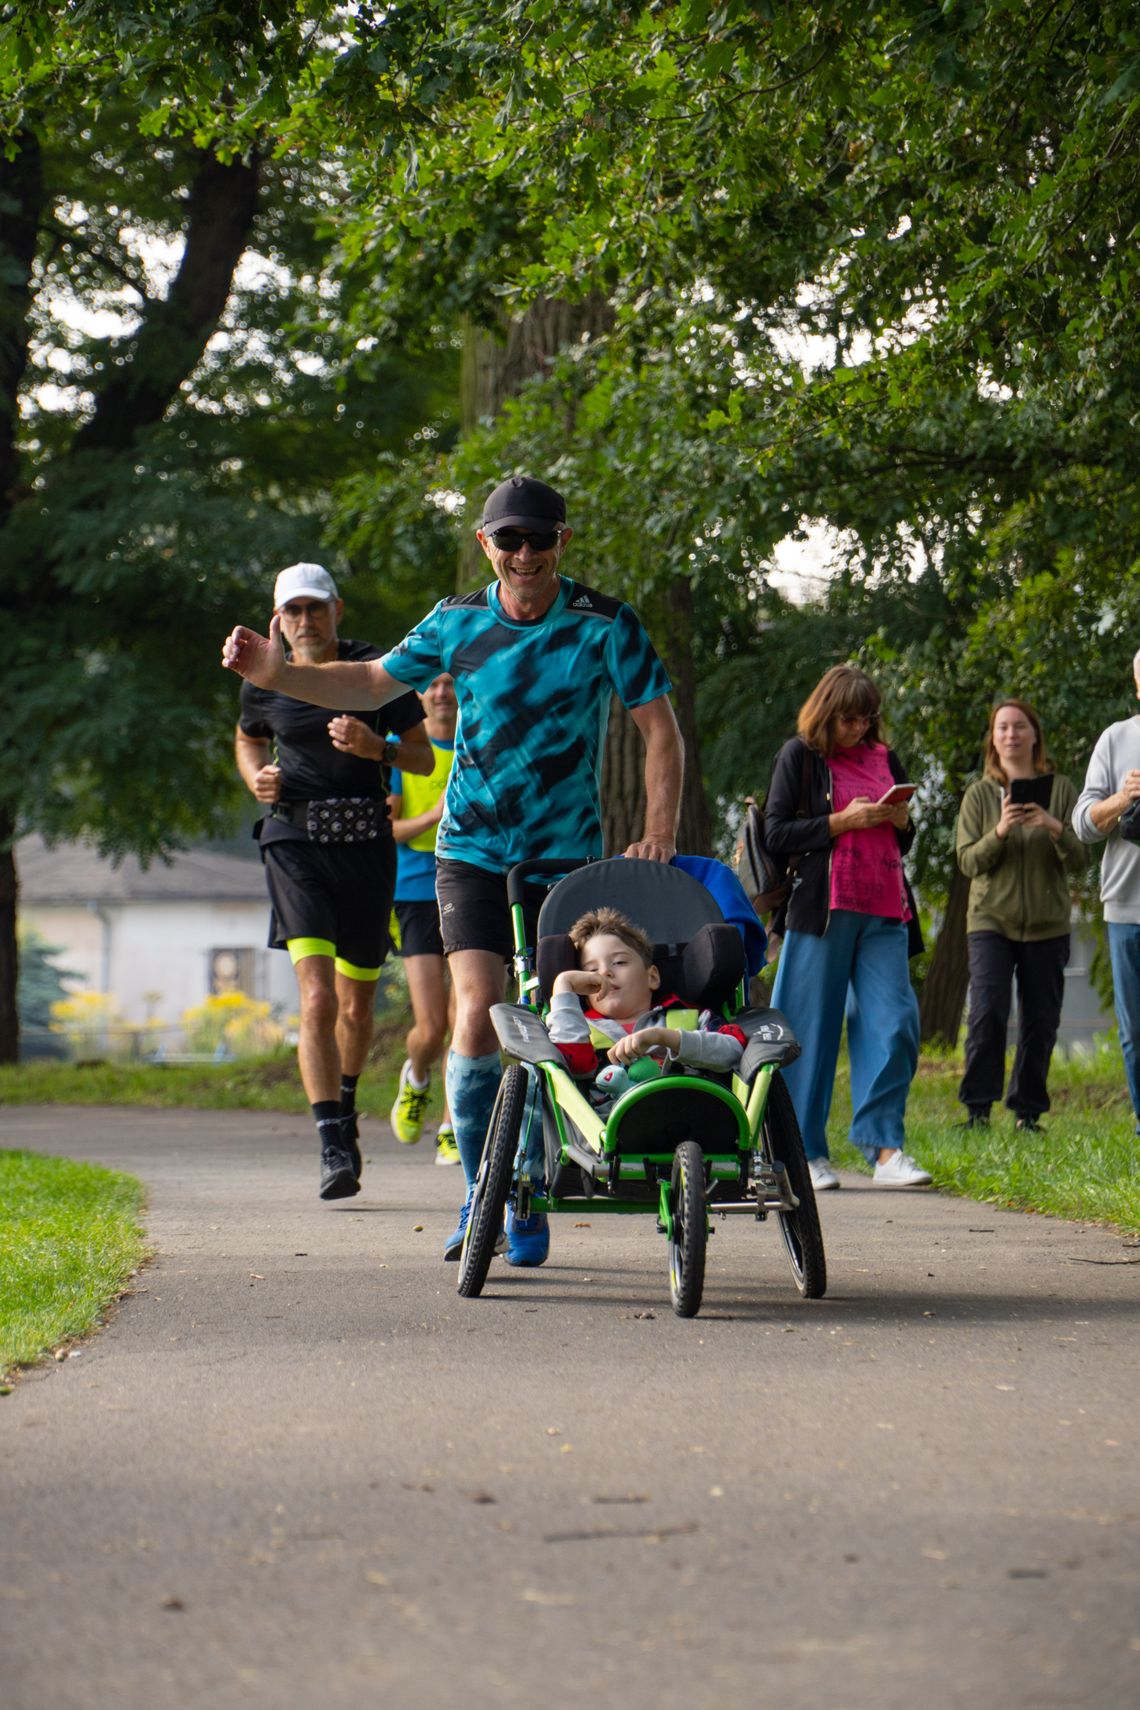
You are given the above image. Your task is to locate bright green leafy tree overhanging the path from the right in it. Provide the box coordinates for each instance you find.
[8,0,1140,1053]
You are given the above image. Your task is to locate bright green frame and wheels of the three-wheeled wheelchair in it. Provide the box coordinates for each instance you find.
[458,858,827,1318]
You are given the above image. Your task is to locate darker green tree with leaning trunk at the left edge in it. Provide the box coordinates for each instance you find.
[0,9,458,1057]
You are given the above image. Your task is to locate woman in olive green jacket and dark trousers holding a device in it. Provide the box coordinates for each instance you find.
[957,699,1087,1132]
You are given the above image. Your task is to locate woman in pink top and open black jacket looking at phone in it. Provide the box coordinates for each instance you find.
[764,665,930,1192]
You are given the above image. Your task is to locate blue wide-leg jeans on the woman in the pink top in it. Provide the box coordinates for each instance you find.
[773,908,918,1165]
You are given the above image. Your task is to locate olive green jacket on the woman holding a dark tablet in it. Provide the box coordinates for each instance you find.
[957,771,1087,944]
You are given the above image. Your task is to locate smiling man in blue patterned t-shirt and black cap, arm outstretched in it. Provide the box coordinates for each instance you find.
[222,475,684,1265]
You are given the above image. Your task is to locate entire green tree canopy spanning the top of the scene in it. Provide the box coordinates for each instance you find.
[0,0,1140,1039]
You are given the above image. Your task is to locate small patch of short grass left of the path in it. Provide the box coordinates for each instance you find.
[0,1151,144,1373]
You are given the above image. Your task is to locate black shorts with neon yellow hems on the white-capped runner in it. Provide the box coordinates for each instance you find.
[261,838,397,968]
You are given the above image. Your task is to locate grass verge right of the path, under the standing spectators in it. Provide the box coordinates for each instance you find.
[827,1045,1140,1233]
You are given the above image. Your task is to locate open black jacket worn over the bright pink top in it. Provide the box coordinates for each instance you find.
[764,737,923,956]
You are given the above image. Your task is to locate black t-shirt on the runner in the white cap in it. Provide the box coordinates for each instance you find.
[238,641,424,841]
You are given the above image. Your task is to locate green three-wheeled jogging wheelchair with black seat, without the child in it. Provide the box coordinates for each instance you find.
[458,857,827,1318]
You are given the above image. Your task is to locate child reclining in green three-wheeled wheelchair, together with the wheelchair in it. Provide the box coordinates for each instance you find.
[458,857,827,1317]
